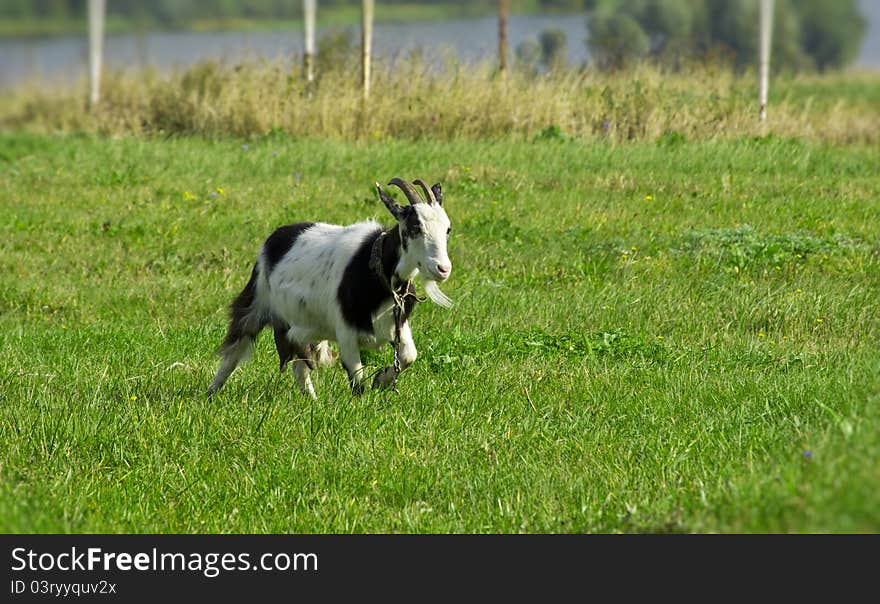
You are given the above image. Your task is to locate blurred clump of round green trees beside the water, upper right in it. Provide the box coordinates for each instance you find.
[586,0,865,70]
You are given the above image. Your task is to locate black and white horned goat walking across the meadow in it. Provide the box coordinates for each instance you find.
[208,178,452,398]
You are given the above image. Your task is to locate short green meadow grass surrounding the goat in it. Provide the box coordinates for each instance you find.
[0,134,880,532]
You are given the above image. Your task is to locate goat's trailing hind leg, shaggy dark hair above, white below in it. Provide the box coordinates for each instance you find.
[208,262,269,396]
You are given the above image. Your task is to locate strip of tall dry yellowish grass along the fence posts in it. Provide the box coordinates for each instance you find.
[0,59,880,142]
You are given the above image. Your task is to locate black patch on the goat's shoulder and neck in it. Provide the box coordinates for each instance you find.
[336,228,412,334]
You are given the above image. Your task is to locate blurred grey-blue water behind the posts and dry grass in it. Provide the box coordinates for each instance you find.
[0,0,880,88]
